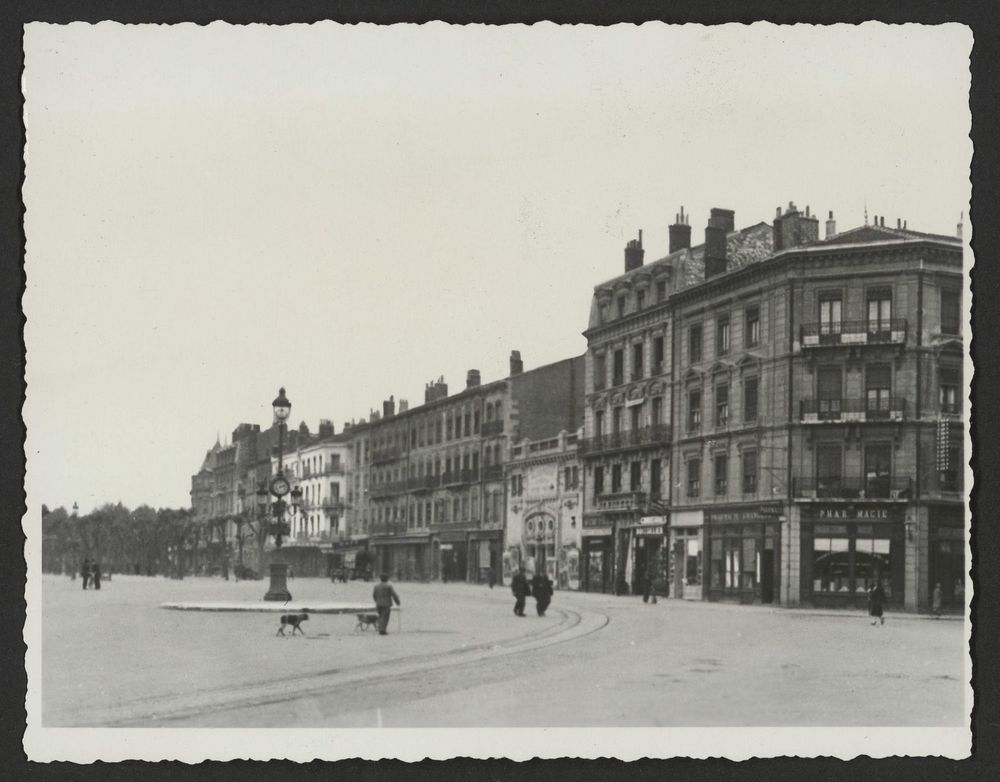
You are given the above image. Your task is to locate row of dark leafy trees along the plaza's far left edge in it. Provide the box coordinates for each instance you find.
[42,503,267,577]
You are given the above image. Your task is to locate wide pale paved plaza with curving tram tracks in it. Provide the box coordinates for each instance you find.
[42,576,968,727]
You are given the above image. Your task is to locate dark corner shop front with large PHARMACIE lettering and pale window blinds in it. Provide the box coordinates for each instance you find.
[799,503,906,608]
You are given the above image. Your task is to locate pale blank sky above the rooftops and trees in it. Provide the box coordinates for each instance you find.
[23,23,972,511]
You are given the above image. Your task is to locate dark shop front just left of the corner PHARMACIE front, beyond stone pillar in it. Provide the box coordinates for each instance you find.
[705,503,782,604]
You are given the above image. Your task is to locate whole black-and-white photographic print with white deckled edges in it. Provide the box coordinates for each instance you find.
[22,21,978,763]
